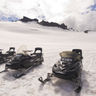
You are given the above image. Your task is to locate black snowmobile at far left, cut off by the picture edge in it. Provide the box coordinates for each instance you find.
[0,47,16,64]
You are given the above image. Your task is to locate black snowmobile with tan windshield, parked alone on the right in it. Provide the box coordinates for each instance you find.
[38,49,83,93]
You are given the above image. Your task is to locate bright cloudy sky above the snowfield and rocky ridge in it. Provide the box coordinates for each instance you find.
[0,0,96,30]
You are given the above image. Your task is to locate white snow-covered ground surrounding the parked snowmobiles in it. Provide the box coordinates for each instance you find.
[0,22,96,96]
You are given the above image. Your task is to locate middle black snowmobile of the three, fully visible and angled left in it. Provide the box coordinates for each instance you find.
[1,47,44,78]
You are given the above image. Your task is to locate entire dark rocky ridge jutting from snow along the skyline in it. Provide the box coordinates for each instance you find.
[20,16,67,29]
